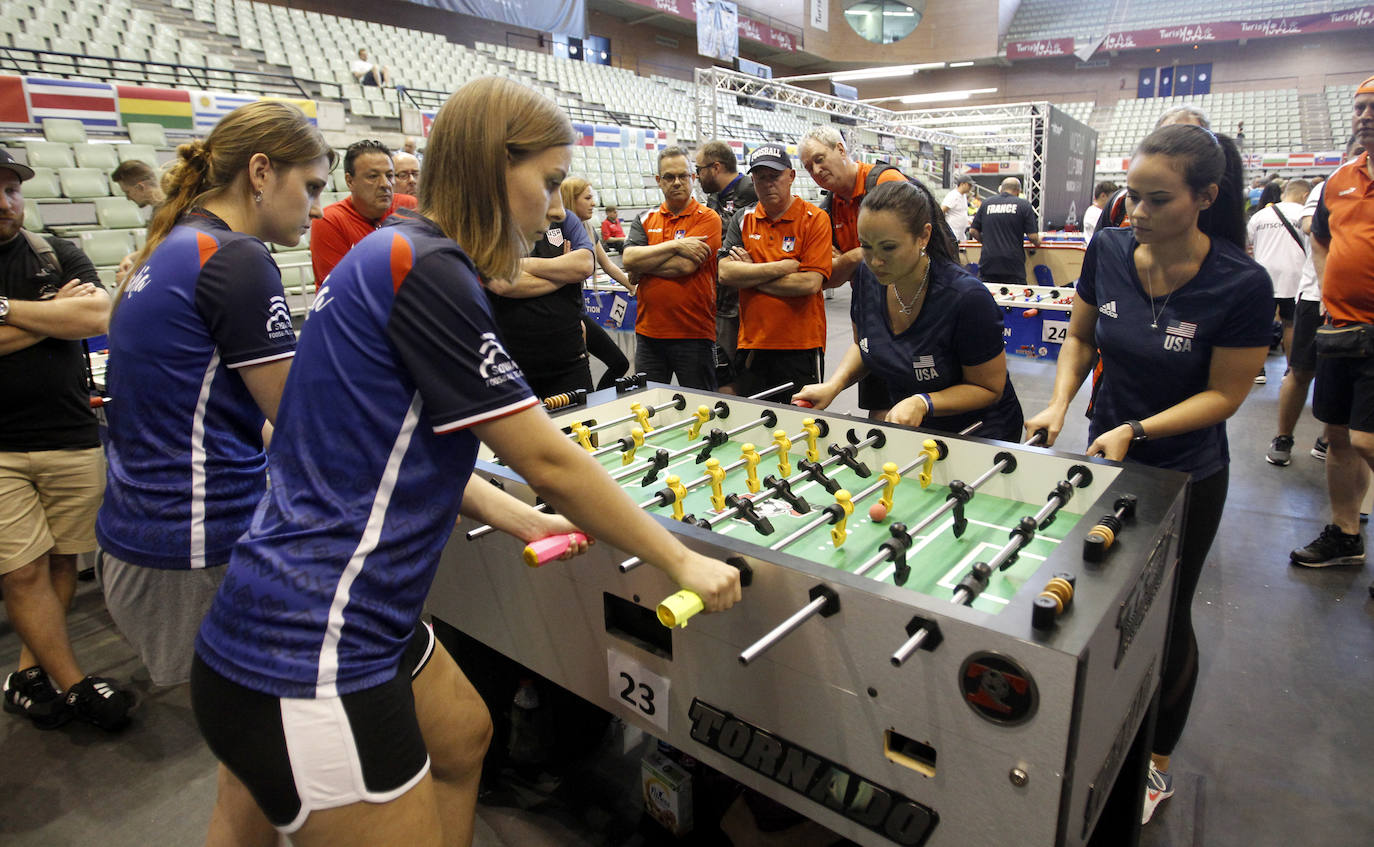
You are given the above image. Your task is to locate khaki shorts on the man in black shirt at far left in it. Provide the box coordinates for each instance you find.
[0,447,104,575]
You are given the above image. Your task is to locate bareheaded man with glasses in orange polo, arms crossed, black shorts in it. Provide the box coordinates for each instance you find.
[624,147,720,391]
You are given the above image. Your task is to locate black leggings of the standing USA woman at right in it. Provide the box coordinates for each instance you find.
[1153,468,1231,756]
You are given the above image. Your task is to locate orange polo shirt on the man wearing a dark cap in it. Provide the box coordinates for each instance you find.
[739,197,831,351]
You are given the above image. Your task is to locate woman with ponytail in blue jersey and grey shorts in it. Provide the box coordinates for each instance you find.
[96,102,334,685]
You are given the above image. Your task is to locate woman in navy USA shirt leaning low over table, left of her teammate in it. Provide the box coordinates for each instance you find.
[793,182,1021,441]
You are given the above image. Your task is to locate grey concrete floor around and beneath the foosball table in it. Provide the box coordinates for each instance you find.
[0,292,1374,847]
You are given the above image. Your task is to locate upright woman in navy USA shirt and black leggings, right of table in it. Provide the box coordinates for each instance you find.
[1025,125,1274,821]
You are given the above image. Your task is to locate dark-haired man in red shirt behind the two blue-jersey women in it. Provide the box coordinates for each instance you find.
[311,140,415,285]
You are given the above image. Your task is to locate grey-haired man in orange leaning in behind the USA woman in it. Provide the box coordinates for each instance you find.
[800,127,907,421]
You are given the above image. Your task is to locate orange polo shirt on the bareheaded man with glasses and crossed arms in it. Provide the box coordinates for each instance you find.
[627,198,720,341]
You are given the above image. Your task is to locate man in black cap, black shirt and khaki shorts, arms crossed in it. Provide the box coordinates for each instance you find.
[0,151,133,730]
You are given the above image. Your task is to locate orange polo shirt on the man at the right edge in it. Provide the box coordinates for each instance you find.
[1312,153,1374,326]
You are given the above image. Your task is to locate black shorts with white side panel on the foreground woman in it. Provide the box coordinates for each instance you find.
[191,623,434,833]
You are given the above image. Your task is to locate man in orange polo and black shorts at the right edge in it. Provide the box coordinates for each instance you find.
[1290,77,1374,569]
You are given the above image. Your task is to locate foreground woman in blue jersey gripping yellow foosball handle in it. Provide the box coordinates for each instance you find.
[191,78,739,847]
